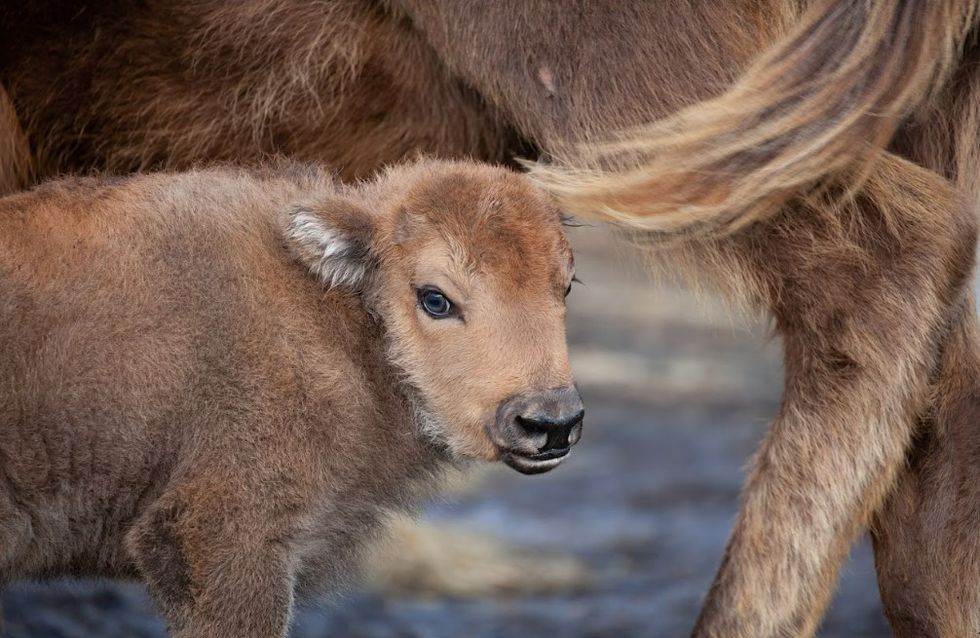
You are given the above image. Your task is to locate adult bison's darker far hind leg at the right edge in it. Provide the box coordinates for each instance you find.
[872,302,980,638]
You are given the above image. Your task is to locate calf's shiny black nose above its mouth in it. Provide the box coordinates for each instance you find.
[500,386,585,459]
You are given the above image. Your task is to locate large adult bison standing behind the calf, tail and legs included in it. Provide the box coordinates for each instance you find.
[0,0,980,637]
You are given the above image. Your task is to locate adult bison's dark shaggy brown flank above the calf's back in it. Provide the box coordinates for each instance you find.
[0,0,511,178]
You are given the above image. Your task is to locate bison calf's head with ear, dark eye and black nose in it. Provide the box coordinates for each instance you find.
[285,161,583,474]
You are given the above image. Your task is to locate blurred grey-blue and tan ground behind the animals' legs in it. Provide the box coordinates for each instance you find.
[3,227,890,638]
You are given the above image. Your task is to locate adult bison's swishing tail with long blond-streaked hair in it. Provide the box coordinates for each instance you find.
[531,0,980,233]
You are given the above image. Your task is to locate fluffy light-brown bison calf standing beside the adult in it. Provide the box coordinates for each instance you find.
[0,162,583,638]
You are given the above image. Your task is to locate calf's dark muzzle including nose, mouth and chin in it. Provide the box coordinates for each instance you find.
[492,386,585,474]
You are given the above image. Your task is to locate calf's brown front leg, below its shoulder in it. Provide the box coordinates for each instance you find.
[128,485,293,638]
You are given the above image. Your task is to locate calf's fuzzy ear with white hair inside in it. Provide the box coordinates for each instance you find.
[283,196,374,289]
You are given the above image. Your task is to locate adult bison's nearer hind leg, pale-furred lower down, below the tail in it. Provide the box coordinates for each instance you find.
[694,158,975,638]
